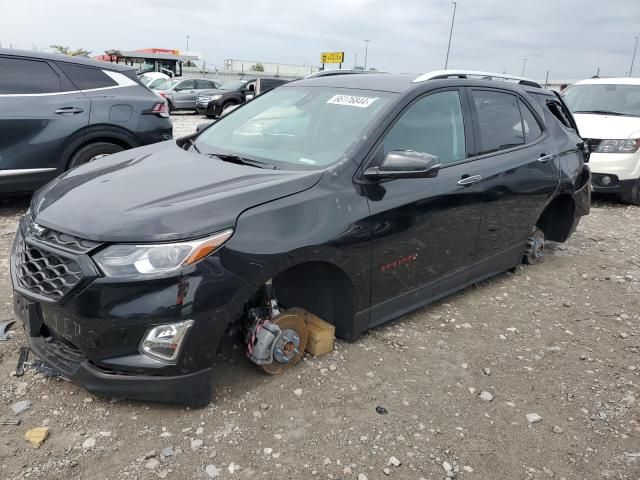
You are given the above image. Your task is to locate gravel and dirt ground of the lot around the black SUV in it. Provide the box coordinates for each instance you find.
[0,116,640,480]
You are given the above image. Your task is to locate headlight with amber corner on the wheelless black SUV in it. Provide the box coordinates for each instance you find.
[93,229,233,277]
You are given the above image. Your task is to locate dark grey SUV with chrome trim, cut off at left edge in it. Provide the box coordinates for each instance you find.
[0,49,173,193]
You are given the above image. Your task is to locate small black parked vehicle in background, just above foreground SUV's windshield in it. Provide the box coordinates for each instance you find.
[196,77,288,118]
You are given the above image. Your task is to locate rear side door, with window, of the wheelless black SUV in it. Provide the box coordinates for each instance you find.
[469,88,560,274]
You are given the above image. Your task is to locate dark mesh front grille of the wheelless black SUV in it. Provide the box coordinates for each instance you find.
[15,235,82,300]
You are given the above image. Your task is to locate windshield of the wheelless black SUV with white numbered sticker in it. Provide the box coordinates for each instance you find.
[196,87,396,170]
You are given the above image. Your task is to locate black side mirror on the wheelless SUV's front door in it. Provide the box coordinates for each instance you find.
[364,150,442,180]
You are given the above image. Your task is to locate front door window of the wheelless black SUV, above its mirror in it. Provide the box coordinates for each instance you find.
[383,90,466,163]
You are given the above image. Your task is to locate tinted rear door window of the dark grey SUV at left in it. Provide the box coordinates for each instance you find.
[0,57,60,94]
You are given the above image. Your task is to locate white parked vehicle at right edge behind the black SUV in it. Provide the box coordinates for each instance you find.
[563,78,640,205]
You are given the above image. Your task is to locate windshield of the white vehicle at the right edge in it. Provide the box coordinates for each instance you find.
[563,83,640,116]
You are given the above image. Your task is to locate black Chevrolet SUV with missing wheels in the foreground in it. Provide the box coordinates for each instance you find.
[11,72,591,405]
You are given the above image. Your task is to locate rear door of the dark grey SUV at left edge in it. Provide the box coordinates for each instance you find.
[0,56,91,186]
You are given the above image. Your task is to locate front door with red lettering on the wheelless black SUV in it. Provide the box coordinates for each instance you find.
[365,89,482,325]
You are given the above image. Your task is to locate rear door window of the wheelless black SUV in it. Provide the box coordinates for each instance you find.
[473,90,524,155]
